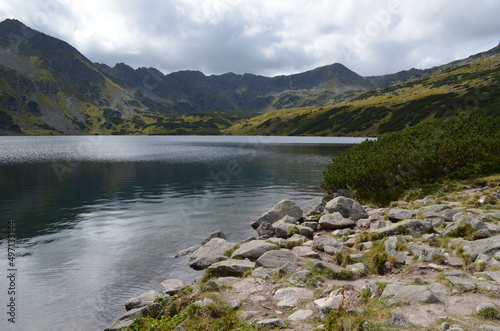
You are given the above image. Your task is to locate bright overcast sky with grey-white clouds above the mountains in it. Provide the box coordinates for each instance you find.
[0,0,500,76]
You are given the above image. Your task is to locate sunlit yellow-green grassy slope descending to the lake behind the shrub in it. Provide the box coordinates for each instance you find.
[224,54,500,136]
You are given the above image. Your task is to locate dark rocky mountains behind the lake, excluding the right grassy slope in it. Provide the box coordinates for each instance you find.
[0,19,498,134]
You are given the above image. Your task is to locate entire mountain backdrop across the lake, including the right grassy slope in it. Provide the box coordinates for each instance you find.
[0,19,500,135]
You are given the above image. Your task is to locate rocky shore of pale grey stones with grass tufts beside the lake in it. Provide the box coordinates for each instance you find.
[106,180,500,331]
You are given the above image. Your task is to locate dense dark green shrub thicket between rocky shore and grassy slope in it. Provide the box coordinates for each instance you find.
[321,111,500,205]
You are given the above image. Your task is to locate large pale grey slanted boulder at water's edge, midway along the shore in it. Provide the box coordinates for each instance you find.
[189,238,234,270]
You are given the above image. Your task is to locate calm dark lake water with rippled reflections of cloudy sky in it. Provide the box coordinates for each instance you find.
[0,136,368,331]
